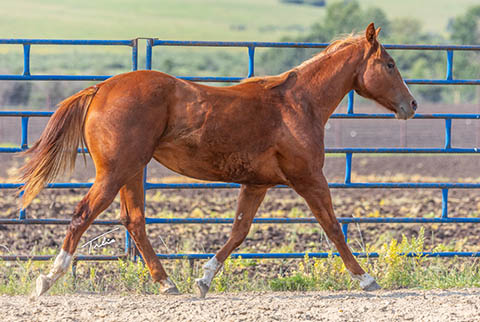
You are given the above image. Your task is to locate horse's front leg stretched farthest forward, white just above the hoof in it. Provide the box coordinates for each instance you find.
[291,173,380,291]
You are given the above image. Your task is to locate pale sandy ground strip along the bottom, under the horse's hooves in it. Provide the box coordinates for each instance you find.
[0,289,480,322]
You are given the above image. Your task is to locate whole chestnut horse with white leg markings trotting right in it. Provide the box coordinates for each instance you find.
[22,23,417,297]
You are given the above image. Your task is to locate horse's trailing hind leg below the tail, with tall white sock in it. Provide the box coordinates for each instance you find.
[36,176,120,296]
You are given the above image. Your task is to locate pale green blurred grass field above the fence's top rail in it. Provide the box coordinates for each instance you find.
[0,0,478,41]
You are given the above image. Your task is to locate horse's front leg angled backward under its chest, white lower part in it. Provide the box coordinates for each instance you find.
[196,185,269,298]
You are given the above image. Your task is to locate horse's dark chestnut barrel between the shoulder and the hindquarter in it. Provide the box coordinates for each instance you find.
[154,82,284,184]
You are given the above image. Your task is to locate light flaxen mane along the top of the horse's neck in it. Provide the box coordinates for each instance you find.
[241,34,364,88]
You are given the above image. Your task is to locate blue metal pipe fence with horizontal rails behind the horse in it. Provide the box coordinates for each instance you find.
[0,38,480,260]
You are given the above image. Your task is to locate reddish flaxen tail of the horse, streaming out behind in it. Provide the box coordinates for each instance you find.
[20,85,98,208]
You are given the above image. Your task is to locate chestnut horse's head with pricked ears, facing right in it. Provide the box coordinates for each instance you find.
[354,23,417,120]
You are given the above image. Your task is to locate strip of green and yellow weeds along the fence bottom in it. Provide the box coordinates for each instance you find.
[0,229,480,295]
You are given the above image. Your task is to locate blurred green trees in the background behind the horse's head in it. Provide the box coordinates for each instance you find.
[259,1,480,103]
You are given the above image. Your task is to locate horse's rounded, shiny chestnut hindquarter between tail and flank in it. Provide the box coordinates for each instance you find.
[84,71,175,173]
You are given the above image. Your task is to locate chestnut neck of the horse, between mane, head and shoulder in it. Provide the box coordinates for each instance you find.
[295,46,363,124]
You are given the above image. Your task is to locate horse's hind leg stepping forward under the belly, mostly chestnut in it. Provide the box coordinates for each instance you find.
[120,170,180,294]
